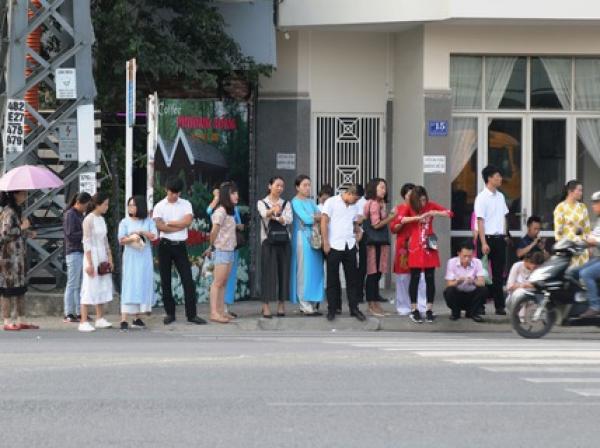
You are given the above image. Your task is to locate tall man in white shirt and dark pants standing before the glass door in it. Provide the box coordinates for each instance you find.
[475,165,508,315]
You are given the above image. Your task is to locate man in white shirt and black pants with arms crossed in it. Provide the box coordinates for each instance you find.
[152,177,206,325]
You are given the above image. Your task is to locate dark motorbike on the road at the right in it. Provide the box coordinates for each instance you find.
[508,239,600,339]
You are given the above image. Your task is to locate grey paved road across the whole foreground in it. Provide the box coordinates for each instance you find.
[0,331,600,448]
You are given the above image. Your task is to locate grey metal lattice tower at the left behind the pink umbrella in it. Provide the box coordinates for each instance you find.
[0,0,96,283]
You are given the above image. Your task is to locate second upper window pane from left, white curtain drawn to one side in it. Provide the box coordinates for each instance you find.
[485,56,527,110]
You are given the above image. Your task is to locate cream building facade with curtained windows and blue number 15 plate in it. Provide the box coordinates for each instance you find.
[257,0,600,266]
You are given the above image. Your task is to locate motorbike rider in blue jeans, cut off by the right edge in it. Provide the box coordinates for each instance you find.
[577,191,600,318]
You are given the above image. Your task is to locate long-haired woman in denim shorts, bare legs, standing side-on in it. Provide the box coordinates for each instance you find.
[207,182,239,324]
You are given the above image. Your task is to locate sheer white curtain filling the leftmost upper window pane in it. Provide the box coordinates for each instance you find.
[450,56,482,109]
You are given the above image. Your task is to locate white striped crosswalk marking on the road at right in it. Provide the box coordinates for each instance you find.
[323,335,600,399]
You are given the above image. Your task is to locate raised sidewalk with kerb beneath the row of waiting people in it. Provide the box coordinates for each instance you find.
[21,291,598,334]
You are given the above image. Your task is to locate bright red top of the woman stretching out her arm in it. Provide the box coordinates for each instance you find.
[396,201,453,269]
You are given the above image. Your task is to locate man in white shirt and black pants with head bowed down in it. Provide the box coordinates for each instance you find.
[321,185,366,321]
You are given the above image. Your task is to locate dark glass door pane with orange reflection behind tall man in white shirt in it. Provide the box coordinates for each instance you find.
[485,116,524,236]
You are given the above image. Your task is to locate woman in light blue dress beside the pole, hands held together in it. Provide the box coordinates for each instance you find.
[119,196,158,331]
